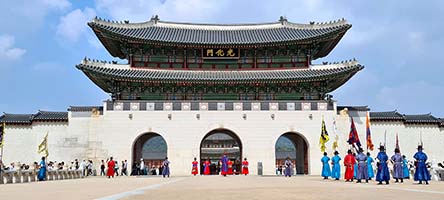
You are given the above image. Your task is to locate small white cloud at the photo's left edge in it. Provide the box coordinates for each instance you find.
[0,35,26,60]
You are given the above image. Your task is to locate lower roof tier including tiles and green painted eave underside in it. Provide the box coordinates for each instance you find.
[76,59,364,92]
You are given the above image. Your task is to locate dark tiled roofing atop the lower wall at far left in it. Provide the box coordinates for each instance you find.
[0,111,68,124]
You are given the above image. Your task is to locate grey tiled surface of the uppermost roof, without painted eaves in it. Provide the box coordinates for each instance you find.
[88,18,351,45]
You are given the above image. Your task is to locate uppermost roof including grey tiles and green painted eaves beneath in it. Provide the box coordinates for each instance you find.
[88,17,352,59]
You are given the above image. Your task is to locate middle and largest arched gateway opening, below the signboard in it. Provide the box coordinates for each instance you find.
[200,129,242,175]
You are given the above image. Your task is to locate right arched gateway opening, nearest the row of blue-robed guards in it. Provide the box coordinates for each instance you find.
[275,132,309,174]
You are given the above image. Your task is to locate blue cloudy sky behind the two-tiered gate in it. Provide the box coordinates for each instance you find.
[0,0,444,117]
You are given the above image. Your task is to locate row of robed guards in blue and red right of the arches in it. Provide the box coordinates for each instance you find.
[321,145,431,185]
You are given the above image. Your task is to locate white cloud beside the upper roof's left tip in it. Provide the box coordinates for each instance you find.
[56,7,96,42]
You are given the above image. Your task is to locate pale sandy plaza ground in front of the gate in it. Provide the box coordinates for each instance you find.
[0,176,444,200]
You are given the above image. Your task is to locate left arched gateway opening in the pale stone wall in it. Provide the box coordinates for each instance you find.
[132,132,168,173]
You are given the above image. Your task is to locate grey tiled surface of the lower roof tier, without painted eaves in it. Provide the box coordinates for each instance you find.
[76,60,364,83]
